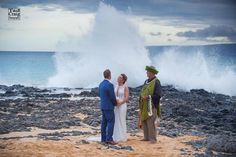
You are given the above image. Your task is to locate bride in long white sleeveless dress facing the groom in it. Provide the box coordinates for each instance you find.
[113,74,129,142]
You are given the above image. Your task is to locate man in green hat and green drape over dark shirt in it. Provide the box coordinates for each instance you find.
[138,66,161,143]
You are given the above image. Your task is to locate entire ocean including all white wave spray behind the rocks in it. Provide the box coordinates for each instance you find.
[0,3,236,95]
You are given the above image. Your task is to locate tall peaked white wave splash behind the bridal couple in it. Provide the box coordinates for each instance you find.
[48,3,151,87]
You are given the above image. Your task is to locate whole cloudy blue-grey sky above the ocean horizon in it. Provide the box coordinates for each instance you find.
[0,0,236,51]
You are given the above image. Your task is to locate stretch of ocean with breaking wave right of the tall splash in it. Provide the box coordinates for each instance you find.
[150,44,236,95]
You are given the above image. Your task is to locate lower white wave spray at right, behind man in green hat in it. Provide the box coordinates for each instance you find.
[153,48,236,95]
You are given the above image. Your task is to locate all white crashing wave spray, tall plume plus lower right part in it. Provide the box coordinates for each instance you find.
[48,3,236,95]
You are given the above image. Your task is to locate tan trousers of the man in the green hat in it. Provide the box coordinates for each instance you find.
[142,107,157,141]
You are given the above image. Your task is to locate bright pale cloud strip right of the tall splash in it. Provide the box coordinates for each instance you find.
[130,16,211,45]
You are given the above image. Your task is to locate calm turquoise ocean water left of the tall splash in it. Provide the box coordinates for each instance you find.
[0,51,55,86]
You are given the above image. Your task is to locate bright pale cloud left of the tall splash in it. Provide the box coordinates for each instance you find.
[0,6,94,51]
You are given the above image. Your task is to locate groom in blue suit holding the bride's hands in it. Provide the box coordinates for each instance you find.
[99,69,117,145]
